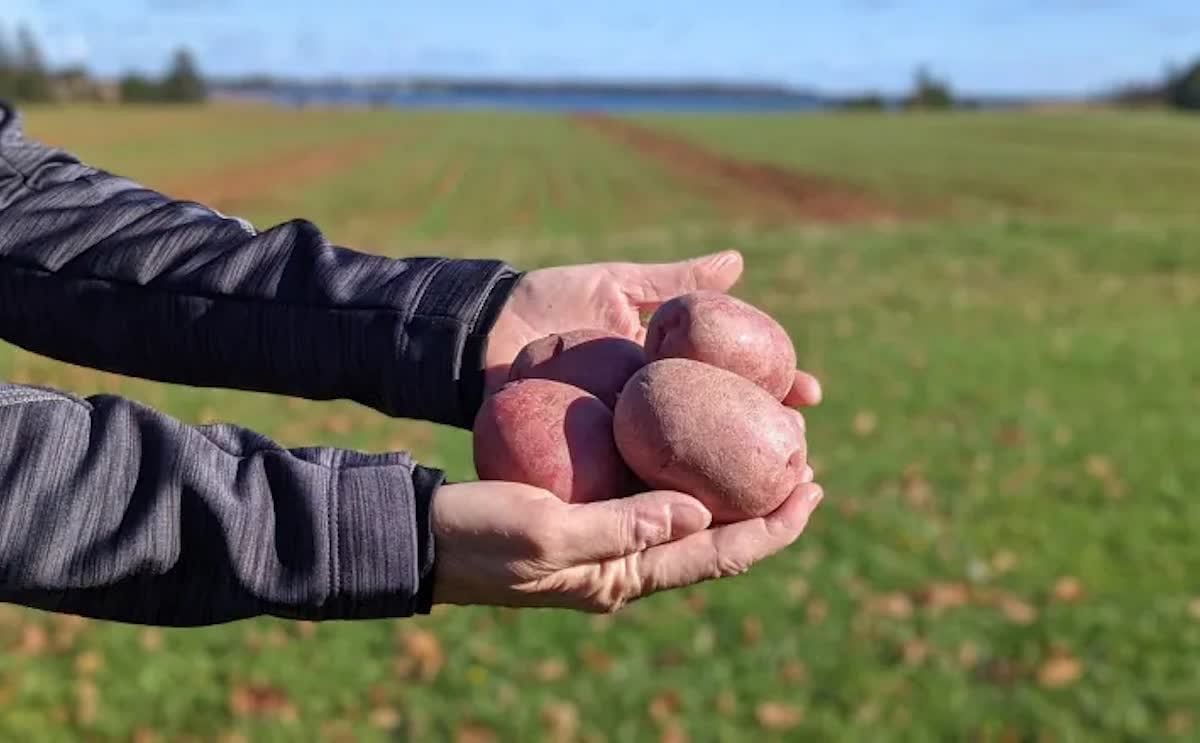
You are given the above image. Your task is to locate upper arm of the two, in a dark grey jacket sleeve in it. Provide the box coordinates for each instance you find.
[0,104,517,426]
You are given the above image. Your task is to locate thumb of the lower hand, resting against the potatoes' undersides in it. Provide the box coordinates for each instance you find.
[560,491,713,565]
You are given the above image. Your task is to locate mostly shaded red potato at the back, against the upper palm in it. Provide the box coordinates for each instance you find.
[509,328,646,408]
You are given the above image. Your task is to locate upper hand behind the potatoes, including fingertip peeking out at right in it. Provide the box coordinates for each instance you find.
[485,251,821,406]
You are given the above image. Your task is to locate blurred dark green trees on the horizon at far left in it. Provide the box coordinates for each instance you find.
[0,26,209,103]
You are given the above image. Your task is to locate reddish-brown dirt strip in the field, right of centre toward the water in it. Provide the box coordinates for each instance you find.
[574,114,898,223]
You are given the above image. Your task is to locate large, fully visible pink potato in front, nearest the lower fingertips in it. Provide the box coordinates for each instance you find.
[613,359,808,523]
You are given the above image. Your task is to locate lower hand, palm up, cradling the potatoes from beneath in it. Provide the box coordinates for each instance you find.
[432,481,822,612]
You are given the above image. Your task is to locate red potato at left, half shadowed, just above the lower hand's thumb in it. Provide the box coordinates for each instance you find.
[474,379,635,503]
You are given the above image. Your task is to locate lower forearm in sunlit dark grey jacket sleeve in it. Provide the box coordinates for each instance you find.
[0,385,442,627]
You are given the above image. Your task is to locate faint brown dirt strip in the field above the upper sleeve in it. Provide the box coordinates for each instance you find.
[155,133,397,210]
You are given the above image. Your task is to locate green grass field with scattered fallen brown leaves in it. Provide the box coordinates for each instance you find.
[0,102,1200,743]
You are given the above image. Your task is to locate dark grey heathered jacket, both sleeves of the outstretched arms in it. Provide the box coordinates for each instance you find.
[0,104,518,625]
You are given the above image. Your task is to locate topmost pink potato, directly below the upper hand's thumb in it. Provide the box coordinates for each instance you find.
[646,292,796,400]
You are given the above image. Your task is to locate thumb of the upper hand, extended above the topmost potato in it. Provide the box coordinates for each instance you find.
[614,250,744,307]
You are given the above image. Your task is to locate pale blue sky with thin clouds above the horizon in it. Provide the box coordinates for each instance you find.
[0,0,1200,94]
